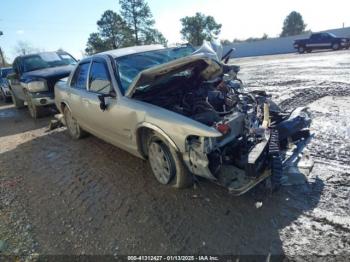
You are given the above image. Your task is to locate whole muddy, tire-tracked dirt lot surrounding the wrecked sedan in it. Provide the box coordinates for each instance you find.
[0,51,350,260]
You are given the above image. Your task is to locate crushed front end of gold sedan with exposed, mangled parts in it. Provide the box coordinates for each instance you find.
[184,83,310,195]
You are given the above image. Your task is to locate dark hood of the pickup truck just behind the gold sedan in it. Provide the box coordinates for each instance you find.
[21,65,74,83]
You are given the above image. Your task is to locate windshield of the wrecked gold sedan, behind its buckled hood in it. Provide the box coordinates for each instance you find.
[116,46,194,92]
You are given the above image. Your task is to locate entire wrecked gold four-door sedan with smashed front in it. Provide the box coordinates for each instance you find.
[55,45,310,195]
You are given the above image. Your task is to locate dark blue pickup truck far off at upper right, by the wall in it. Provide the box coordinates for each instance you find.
[294,32,350,54]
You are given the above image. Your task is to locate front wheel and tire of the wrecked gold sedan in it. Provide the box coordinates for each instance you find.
[148,134,193,188]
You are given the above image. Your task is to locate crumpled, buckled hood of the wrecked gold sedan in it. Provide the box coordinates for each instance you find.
[126,55,222,97]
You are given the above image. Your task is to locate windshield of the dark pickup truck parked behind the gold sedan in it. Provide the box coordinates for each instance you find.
[23,52,77,72]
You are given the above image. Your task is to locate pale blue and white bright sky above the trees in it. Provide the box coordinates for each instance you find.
[0,0,350,62]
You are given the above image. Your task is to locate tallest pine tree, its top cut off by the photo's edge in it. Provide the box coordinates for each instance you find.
[119,0,166,45]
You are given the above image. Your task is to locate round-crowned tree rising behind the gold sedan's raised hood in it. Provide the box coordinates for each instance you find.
[180,13,222,46]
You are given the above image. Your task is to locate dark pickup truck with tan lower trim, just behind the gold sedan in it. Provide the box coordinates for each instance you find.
[7,51,77,119]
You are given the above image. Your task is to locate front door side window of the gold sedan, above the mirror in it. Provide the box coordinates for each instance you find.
[89,62,111,95]
